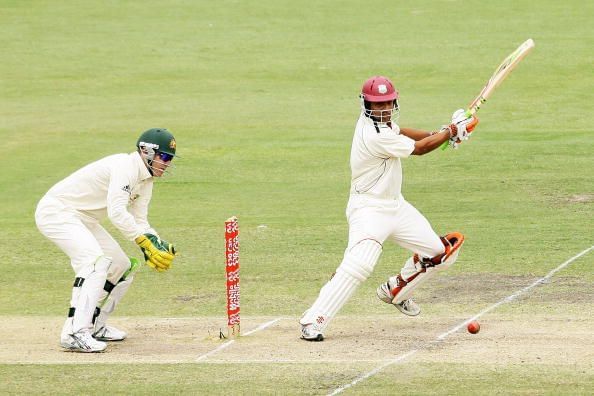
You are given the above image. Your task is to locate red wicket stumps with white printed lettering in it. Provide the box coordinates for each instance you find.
[225,216,240,338]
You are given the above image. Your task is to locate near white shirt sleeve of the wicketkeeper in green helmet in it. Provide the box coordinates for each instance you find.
[107,156,143,241]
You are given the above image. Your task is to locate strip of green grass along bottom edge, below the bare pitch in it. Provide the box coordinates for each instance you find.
[0,362,594,395]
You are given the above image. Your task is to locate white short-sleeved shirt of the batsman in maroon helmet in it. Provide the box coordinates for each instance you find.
[351,114,415,200]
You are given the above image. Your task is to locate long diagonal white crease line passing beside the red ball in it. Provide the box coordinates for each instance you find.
[329,246,594,396]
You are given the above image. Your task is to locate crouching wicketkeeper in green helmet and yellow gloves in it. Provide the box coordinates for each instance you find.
[35,129,176,352]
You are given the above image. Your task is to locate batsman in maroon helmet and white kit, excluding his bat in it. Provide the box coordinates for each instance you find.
[300,76,478,341]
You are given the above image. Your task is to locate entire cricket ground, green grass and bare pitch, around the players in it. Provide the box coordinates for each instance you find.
[0,0,594,394]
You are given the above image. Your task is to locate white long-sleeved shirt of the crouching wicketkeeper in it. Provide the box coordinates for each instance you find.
[46,152,156,240]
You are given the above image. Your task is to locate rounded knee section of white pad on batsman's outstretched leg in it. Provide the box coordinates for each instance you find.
[337,239,382,282]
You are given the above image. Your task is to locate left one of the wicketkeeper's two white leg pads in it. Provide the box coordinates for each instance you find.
[72,256,111,333]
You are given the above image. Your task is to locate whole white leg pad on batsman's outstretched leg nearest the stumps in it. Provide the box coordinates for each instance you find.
[300,239,382,332]
